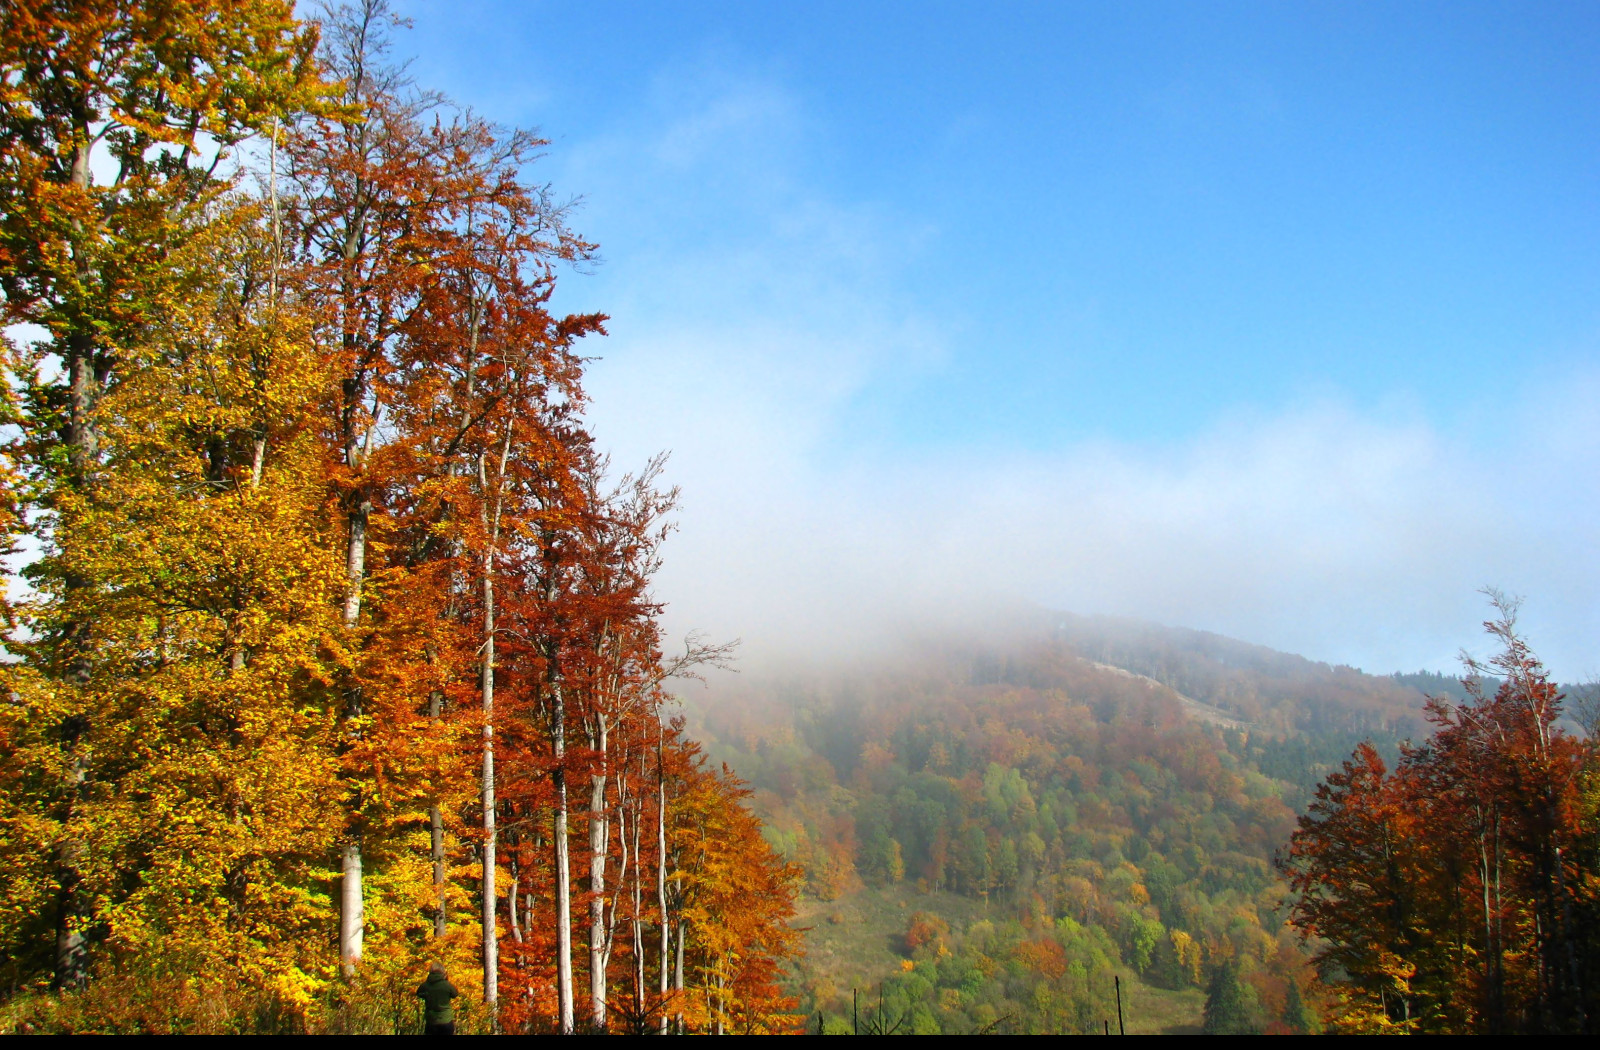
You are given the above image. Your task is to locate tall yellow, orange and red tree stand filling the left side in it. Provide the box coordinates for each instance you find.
[0,0,795,1032]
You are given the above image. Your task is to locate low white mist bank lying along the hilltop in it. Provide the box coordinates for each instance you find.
[600,355,1600,680]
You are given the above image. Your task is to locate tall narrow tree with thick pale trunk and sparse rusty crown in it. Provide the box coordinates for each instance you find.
[285,0,450,975]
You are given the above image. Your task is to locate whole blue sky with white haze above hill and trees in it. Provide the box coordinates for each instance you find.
[400,0,1600,677]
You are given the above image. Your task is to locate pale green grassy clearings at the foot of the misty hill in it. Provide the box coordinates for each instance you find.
[795,885,1205,1036]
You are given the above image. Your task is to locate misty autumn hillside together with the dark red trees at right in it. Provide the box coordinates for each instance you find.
[690,605,1600,1034]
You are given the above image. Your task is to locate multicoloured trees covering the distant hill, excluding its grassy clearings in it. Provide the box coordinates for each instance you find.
[699,642,1324,1032]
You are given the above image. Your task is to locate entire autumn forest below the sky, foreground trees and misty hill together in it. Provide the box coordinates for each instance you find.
[0,0,1600,1034]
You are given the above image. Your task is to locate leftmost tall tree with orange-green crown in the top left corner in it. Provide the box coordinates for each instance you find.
[0,0,320,986]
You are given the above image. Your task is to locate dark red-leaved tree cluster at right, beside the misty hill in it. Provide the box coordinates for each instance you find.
[1288,595,1600,1032]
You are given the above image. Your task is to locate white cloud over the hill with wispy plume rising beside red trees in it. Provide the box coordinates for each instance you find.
[560,70,1600,677]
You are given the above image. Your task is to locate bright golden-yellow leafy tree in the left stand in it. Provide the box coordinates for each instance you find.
[30,203,347,1007]
